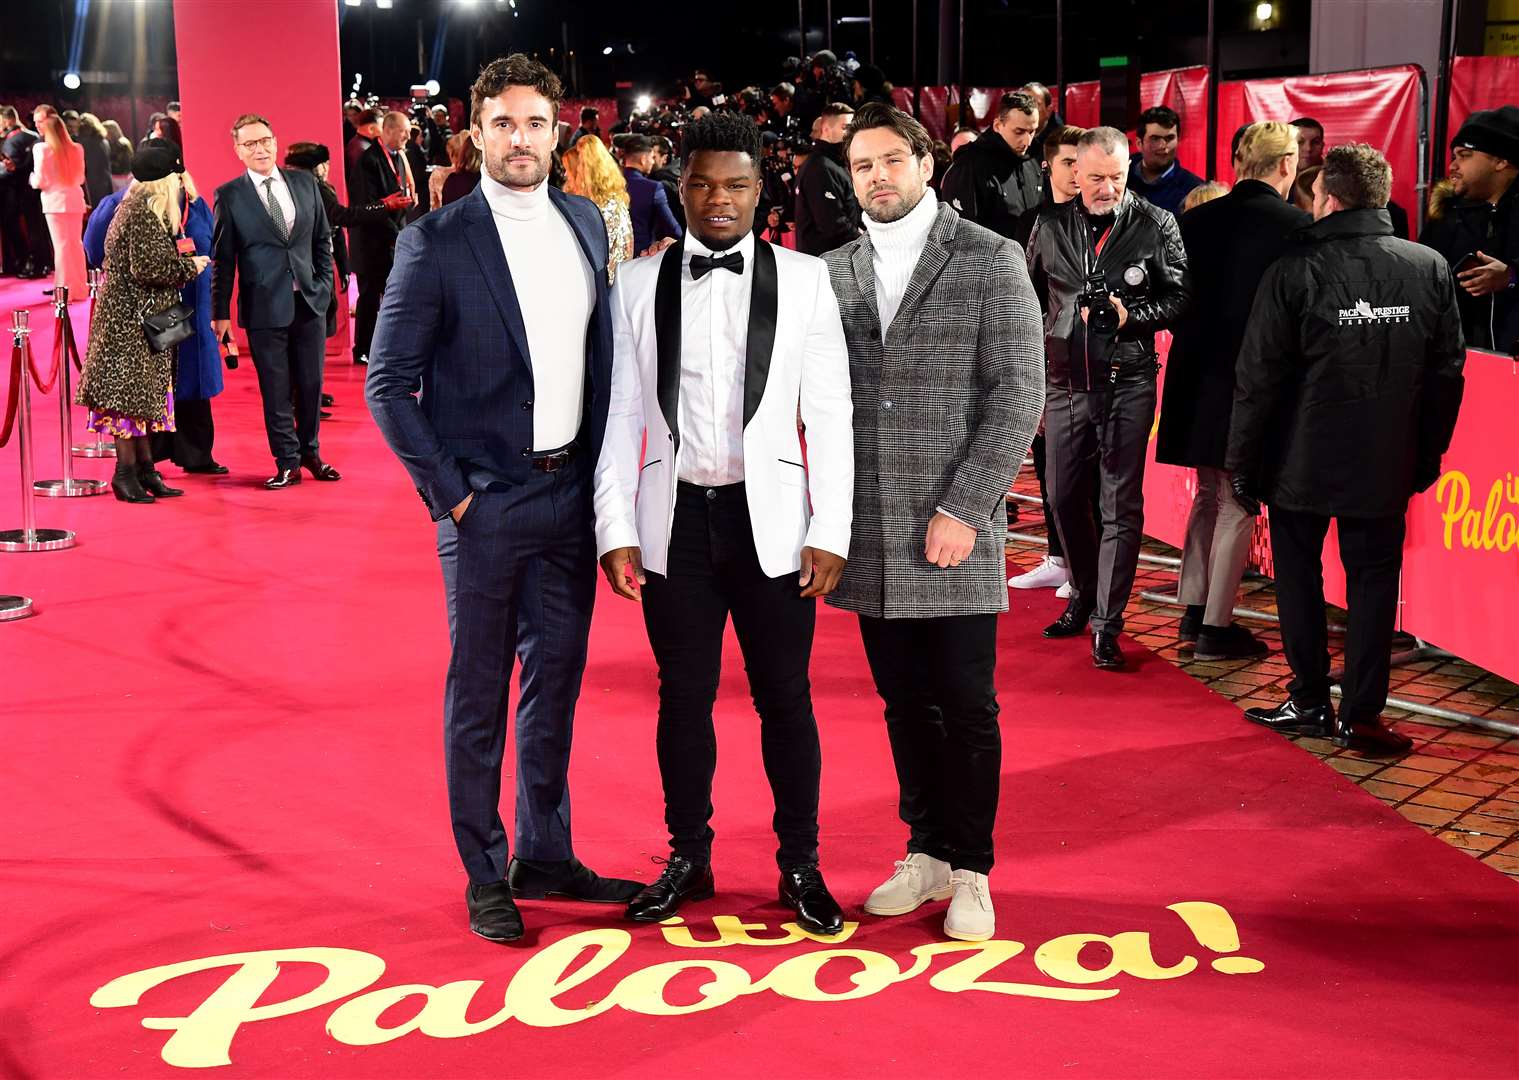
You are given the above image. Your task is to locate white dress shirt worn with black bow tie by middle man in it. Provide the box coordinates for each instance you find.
[679,232,755,488]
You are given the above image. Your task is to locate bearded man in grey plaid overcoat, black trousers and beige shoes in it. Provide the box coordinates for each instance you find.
[826,105,1044,940]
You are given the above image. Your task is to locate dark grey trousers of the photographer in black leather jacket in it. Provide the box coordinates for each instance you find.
[1045,372,1154,633]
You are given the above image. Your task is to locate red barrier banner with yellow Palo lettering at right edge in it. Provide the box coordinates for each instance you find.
[1402,349,1519,681]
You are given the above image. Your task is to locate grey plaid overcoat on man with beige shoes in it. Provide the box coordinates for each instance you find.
[825,205,1045,618]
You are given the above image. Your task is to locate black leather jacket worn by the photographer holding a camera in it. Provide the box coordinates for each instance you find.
[1028,191,1191,390]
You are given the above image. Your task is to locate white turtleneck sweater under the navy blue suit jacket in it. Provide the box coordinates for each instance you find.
[480,173,595,450]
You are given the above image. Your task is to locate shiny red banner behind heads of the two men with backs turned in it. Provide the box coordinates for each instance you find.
[1215,64,1420,228]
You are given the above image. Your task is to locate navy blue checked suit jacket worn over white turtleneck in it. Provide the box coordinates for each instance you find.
[365,187,612,521]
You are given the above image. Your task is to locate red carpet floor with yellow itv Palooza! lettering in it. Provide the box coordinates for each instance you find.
[0,274,1519,1077]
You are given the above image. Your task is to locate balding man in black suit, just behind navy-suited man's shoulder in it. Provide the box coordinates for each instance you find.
[348,112,416,363]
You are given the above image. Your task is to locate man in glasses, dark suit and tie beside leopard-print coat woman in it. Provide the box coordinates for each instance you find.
[211,112,340,491]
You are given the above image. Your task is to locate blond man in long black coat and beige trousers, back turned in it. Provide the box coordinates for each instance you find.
[1154,122,1314,661]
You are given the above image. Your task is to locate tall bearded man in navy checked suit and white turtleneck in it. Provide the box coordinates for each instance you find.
[365,55,639,942]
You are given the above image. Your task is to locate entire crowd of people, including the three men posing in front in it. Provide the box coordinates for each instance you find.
[0,52,1519,940]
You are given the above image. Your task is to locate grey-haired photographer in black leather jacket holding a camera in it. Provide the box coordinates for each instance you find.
[1028,128,1189,670]
